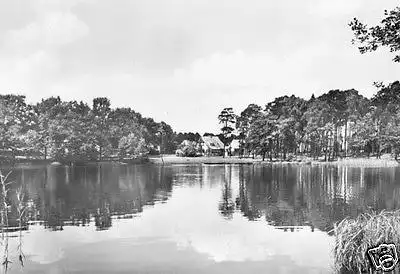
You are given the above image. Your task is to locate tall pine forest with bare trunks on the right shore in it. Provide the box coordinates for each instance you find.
[228,81,400,160]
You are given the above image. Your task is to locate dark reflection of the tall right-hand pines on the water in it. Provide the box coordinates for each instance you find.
[236,165,400,231]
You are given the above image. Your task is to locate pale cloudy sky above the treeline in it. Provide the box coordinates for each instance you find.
[0,0,400,133]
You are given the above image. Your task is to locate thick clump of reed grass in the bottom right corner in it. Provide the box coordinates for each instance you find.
[334,210,400,273]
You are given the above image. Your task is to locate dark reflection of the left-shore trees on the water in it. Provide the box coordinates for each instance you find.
[3,165,172,231]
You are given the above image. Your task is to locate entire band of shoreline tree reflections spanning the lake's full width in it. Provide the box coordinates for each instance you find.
[3,164,400,237]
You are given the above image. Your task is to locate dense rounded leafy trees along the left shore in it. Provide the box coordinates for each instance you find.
[0,95,199,162]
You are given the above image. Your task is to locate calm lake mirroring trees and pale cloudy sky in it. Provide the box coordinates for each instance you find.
[2,164,400,274]
